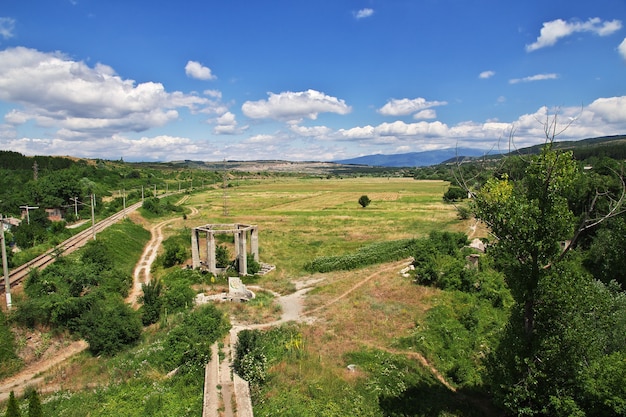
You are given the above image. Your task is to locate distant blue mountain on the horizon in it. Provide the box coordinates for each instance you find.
[333,148,493,168]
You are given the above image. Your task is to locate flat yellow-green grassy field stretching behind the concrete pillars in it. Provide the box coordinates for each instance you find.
[186,178,465,278]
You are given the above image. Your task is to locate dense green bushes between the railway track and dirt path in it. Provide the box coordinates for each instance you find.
[13,221,149,354]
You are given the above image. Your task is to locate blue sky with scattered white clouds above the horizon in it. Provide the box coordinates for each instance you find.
[0,0,626,161]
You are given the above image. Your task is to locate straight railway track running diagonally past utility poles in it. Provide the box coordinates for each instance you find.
[0,201,142,292]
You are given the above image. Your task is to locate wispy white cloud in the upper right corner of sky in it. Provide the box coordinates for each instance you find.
[526,17,622,52]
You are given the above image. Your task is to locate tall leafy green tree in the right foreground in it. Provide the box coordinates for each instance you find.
[474,125,626,415]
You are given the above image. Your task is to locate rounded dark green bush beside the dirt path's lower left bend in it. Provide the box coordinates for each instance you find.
[78,297,142,355]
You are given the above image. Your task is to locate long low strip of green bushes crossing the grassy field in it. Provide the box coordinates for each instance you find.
[304,239,417,272]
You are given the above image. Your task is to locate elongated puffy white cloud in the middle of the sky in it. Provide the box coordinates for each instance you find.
[241,90,352,122]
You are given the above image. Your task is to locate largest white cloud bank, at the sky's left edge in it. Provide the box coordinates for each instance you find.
[0,47,209,138]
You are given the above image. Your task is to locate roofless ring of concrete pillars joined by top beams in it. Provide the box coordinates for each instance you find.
[191,223,259,276]
